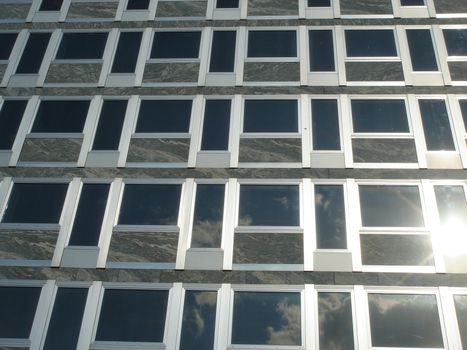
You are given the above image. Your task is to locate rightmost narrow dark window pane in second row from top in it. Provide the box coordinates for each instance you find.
[406,29,438,72]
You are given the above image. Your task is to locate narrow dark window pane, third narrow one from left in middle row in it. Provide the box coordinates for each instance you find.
[201,100,232,151]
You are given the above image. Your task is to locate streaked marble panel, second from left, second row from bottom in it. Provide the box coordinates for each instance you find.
[107,232,178,263]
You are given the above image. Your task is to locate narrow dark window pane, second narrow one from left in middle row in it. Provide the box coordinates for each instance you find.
[92,100,128,151]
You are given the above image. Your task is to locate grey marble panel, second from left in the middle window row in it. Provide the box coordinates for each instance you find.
[127,138,190,163]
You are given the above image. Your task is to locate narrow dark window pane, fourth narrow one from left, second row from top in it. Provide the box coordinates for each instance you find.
[308,30,336,72]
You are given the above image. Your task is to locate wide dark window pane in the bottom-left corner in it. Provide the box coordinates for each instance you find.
[0,287,41,339]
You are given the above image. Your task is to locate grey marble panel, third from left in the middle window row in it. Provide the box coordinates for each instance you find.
[238,138,302,162]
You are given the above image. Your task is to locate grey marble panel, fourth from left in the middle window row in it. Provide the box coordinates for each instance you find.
[352,139,417,163]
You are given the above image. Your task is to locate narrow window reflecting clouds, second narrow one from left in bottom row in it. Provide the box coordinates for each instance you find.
[179,291,217,350]
